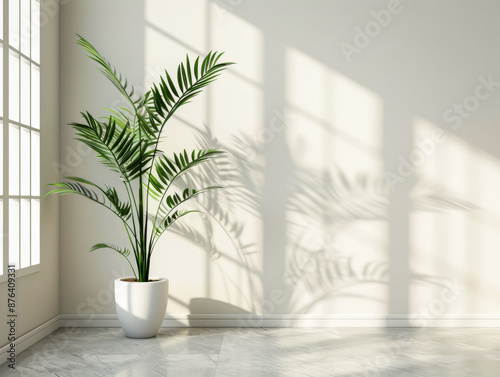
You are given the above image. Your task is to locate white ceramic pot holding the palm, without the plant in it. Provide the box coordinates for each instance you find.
[115,277,168,338]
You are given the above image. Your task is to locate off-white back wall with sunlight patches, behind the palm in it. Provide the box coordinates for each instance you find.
[60,0,500,315]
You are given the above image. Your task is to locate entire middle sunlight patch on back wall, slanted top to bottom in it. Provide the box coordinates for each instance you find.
[285,48,387,314]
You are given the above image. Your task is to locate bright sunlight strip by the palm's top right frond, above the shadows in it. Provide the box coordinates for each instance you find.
[209,4,265,139]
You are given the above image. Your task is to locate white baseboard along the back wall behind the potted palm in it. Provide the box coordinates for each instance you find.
[59,314,500,327]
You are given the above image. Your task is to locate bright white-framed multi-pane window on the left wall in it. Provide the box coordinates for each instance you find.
[0,0,40,275]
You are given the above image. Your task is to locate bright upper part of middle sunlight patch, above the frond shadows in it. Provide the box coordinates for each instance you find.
[285,48,383,174]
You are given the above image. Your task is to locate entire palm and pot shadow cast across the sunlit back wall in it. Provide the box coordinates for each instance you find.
[164,127,476,314]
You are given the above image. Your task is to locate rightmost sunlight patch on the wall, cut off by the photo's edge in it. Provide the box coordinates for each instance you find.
[410,118,500,314]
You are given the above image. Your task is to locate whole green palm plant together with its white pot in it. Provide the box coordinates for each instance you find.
[47,36,233,338]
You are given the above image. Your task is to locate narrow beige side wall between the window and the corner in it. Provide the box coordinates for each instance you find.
[0,0,60,345]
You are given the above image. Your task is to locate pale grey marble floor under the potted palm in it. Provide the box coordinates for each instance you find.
[0,328,500,377]
